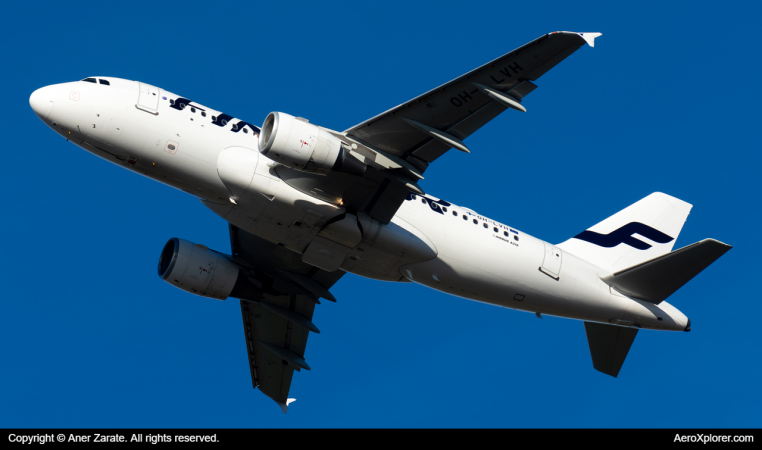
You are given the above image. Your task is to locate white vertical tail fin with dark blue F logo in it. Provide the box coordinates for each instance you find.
[558,192,693,272]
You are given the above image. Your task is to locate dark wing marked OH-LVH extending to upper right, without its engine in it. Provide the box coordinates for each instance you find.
[278,31,600,223]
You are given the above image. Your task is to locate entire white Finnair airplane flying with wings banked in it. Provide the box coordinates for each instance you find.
[29,31,731,413]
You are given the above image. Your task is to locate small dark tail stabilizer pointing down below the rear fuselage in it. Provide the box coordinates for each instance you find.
[585,322,638,378]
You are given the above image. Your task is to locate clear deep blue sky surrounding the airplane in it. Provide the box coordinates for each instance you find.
[0,1,762,428]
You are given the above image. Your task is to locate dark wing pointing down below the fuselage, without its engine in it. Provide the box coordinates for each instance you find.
[230,225,344,413]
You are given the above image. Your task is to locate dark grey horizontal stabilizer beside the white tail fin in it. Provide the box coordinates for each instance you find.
[601,239,732,305]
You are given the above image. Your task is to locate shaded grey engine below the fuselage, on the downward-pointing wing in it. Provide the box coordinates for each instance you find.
[159,238,261,300]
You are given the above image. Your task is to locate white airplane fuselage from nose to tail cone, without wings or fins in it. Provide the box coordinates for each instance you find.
[30,77,688,331]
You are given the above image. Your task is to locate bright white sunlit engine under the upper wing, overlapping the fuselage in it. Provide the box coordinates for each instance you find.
[259,112,367,176]
